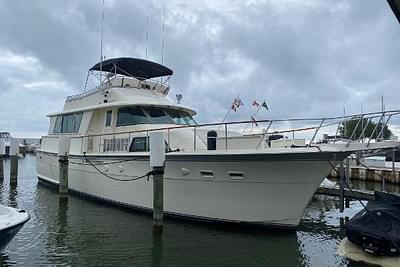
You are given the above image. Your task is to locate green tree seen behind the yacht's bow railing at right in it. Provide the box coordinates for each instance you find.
[339,118,392,140]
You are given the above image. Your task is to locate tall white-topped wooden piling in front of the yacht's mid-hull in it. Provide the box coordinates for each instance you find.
[150,132,165,233]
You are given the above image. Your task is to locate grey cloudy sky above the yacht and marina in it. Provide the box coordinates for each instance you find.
[0,0,400,137]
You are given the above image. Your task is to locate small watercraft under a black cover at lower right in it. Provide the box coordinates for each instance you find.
[344,192,400,256]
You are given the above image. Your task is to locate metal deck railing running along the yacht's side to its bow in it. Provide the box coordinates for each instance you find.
[62,110,400,153]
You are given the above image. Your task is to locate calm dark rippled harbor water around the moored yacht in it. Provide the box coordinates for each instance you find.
[0,155,398,266]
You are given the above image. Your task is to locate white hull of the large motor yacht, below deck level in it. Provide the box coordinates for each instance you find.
[37,151,340,227]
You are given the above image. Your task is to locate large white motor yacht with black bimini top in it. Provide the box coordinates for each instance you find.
[37,58,398,228]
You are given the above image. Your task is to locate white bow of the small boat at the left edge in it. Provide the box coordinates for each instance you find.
[0,205,30,251]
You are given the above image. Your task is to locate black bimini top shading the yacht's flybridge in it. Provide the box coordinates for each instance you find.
[89,57,173,80]
